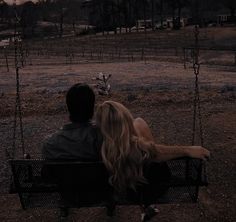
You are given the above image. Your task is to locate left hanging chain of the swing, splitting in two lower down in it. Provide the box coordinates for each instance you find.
[8,3,25,159]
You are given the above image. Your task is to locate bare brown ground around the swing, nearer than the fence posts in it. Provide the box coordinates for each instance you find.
[0,56,236,222]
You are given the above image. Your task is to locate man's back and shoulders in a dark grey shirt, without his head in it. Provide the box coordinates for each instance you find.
[42,122,102,161]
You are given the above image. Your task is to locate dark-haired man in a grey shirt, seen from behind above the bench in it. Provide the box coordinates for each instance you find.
[42,83,102,161]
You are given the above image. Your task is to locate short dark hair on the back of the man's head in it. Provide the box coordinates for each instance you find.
[66,83,95,123]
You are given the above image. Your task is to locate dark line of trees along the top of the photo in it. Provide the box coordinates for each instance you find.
[0,0,236,37]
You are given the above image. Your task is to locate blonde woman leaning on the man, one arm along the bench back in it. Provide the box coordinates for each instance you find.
[96,101,210,192]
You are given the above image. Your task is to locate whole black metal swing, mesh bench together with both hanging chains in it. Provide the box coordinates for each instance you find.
[7,22,207,215]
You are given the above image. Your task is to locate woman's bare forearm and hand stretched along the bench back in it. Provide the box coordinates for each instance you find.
[143,141,210,162]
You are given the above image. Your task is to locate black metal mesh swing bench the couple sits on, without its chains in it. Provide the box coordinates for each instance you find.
[10,158,207,215]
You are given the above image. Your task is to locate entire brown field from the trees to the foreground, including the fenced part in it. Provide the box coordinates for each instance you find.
[0,28,236,222]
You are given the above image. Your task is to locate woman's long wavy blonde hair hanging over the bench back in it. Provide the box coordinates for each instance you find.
[96,101,146,192]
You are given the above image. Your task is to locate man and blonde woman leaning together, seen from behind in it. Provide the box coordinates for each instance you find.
[42,84,210,219]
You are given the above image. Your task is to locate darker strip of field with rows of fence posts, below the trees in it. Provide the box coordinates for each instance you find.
[0,31,236,71]
